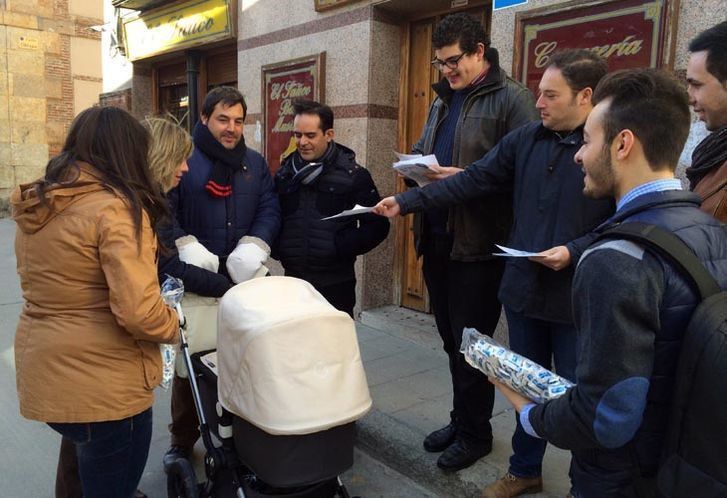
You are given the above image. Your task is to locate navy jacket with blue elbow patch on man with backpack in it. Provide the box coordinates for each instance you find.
[523,191,727,498]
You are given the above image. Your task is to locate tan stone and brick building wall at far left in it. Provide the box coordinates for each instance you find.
[0,0,103,208]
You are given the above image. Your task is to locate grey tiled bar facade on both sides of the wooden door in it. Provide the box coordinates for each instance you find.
[91,0,724,309]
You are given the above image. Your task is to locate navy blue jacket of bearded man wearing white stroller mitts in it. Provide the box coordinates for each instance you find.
[169,148,280,256]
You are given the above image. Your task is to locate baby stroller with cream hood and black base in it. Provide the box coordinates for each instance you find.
[165,277,371,498]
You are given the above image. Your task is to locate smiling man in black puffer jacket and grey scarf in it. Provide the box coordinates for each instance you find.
[272,100,389,317]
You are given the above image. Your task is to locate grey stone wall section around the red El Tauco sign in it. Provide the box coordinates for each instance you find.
[237,0,401,309]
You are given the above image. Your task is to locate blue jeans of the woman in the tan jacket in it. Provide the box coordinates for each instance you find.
[48,408,152,498]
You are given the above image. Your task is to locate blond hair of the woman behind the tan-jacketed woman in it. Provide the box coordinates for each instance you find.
[144,117,194,192]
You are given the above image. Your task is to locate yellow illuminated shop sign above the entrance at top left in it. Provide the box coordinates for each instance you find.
[124,0,233,61]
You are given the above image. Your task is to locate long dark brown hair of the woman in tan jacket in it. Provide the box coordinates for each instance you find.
[36,107,168,247]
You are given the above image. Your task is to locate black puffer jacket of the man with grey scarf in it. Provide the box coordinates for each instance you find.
[273,143,389,286]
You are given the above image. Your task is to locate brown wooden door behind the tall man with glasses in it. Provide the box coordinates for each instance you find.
[396,3,491,311]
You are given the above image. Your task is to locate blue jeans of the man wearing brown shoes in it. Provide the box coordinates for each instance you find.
[505,307,576,477]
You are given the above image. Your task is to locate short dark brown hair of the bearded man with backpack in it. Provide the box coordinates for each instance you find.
[593,69,690,170]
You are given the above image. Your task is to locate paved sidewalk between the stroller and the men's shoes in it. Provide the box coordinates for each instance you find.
[357,306,570,497]
